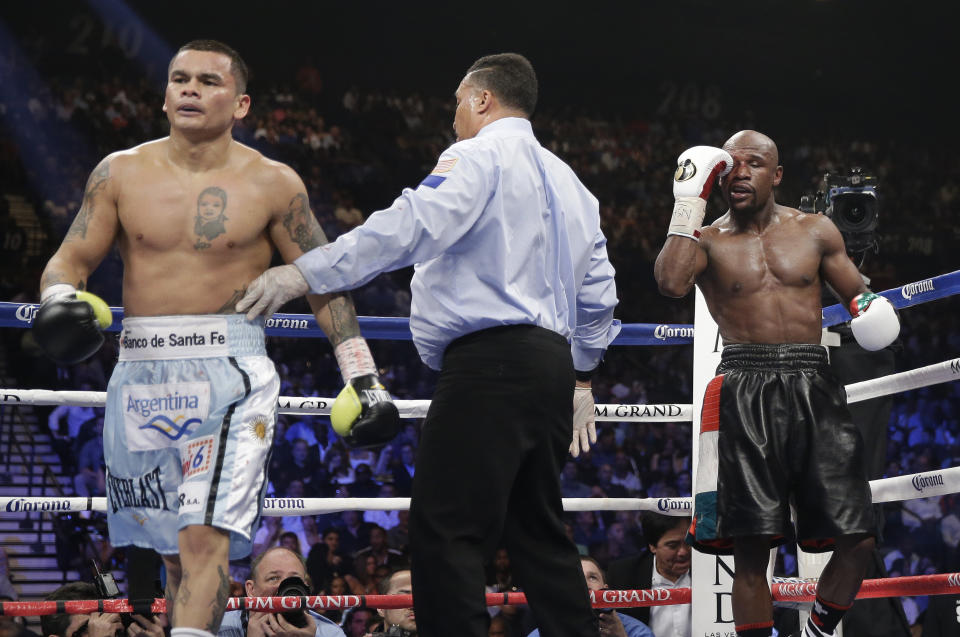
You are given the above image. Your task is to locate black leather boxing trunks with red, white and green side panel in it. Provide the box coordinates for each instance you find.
[687,344,876,554]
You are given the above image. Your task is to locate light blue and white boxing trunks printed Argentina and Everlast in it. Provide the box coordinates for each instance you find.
[103,314,280,559]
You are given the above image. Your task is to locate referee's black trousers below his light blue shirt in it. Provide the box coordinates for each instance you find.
[410,325,598,637]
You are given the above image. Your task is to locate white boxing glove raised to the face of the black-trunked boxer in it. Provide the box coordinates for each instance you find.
[667,146,733,241]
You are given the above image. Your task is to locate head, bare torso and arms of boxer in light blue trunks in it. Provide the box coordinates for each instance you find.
[41,50,350,328]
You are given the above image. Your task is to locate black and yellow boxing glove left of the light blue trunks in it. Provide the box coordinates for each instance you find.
[33,283,113,365]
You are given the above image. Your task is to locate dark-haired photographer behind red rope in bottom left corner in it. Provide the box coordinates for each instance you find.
[40,582,167,637]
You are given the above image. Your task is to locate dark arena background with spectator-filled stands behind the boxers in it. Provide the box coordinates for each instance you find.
[0,0,960,637]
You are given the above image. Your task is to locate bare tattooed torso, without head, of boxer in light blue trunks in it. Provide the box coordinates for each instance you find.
[47,138,325,316]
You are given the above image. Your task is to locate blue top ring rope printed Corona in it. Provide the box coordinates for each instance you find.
[0,270,960,345]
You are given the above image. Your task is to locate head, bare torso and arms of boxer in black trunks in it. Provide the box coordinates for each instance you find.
[655,131,866,344]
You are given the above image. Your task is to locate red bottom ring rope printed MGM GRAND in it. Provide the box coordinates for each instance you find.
[7,573,960,617]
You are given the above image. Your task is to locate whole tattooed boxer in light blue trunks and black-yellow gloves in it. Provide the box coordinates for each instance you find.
[33,40,400,637]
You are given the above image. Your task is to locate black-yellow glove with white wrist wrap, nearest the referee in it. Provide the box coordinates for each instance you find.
[330,337,400,449]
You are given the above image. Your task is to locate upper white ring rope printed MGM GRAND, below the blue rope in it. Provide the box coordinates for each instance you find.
[0,358,960,422]
